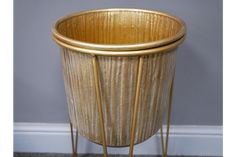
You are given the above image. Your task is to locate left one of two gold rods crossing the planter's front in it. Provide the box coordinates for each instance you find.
[92,56,107,157]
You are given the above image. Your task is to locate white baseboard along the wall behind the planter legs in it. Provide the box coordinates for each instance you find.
[14,123,223,156]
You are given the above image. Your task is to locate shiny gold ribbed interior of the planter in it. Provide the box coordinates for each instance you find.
[58,11,181,44]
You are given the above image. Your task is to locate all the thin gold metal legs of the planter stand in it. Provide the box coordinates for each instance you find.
[70,56,174,157]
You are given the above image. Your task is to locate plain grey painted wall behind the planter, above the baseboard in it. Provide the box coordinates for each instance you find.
[14,0,222,125]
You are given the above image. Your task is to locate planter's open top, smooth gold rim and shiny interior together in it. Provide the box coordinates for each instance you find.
[52,8,186,55]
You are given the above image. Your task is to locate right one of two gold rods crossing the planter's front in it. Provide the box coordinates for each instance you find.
[129,56,143,157]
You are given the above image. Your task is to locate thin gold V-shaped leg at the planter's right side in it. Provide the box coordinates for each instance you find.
[161,73,174,157]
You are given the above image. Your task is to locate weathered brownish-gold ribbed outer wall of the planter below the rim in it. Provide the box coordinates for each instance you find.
[62,49,175,146]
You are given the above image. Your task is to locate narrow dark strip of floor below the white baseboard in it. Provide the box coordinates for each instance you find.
[14,153,221,157]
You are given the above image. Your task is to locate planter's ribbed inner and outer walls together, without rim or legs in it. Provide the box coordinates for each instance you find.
[57,11,180,146]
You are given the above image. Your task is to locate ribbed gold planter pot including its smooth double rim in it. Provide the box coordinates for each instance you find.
[52,9,185,156]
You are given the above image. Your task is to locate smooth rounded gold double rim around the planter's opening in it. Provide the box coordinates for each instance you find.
[52,8,186,56]
